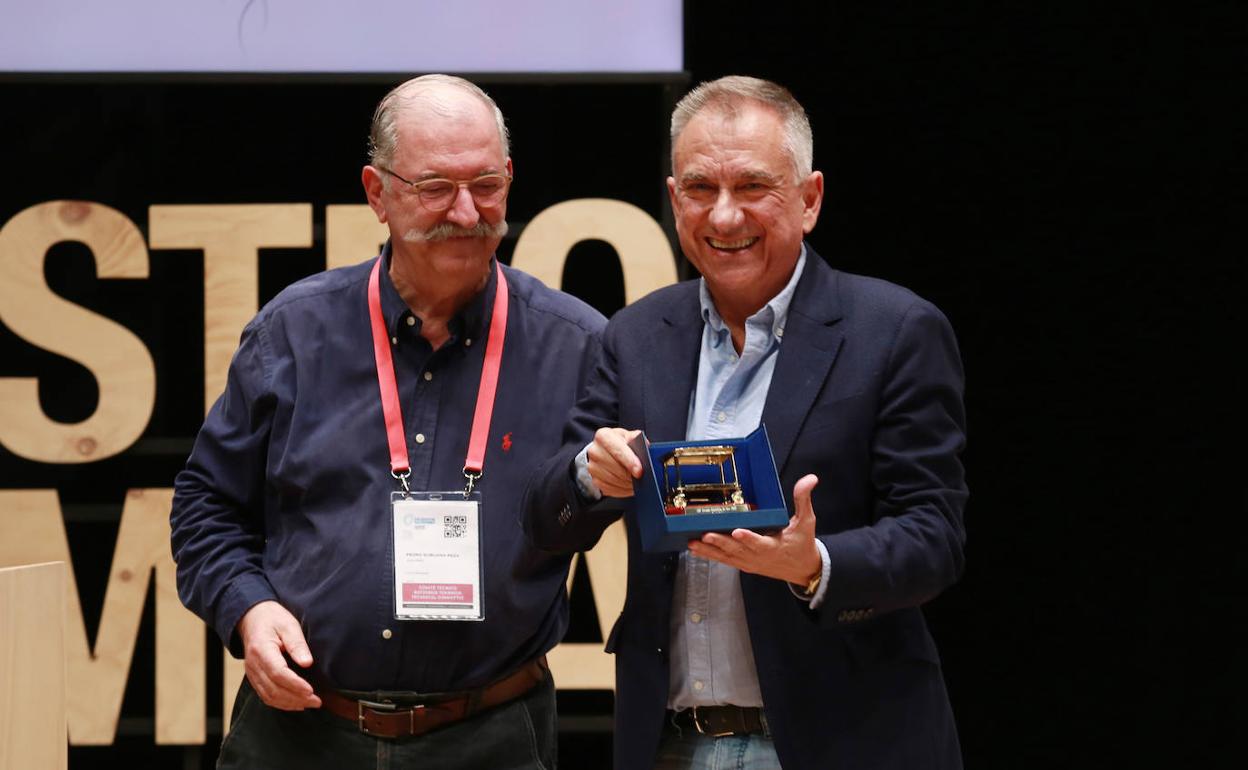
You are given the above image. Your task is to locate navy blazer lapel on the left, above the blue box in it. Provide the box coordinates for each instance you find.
[645,281,703,441]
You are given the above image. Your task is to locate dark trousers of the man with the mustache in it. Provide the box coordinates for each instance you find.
[217,673,557,770]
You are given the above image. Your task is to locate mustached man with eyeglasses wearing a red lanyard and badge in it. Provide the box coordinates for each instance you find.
[171,75,605,769]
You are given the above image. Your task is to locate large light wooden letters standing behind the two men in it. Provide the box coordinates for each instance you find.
[0,198,676,745]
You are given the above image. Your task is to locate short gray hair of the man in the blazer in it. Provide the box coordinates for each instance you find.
[671,75,815,180]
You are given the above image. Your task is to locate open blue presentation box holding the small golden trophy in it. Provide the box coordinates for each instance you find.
[630,426,789,553]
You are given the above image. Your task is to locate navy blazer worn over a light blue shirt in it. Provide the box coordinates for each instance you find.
[524,247,967,770]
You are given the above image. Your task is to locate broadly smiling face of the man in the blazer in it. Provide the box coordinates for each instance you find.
[668,101,824,323]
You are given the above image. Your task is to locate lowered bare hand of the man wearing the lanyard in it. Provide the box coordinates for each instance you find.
[238,602,321,711]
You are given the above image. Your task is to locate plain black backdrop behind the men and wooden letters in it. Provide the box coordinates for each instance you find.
[0,0,1248,769]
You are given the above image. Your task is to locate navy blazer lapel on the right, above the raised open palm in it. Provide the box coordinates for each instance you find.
[763,246,845,473]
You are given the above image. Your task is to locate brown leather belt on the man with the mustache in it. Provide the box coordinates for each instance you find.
[317,658,548,738]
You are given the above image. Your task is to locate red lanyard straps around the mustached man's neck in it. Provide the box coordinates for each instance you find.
[368,257,507,494]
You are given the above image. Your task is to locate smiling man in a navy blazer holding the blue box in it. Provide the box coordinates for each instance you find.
[525,77,967,770]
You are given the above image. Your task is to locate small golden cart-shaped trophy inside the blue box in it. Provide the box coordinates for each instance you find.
[660,446,754,515]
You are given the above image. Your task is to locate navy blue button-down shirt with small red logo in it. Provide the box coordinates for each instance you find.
[171,246,605,691]
